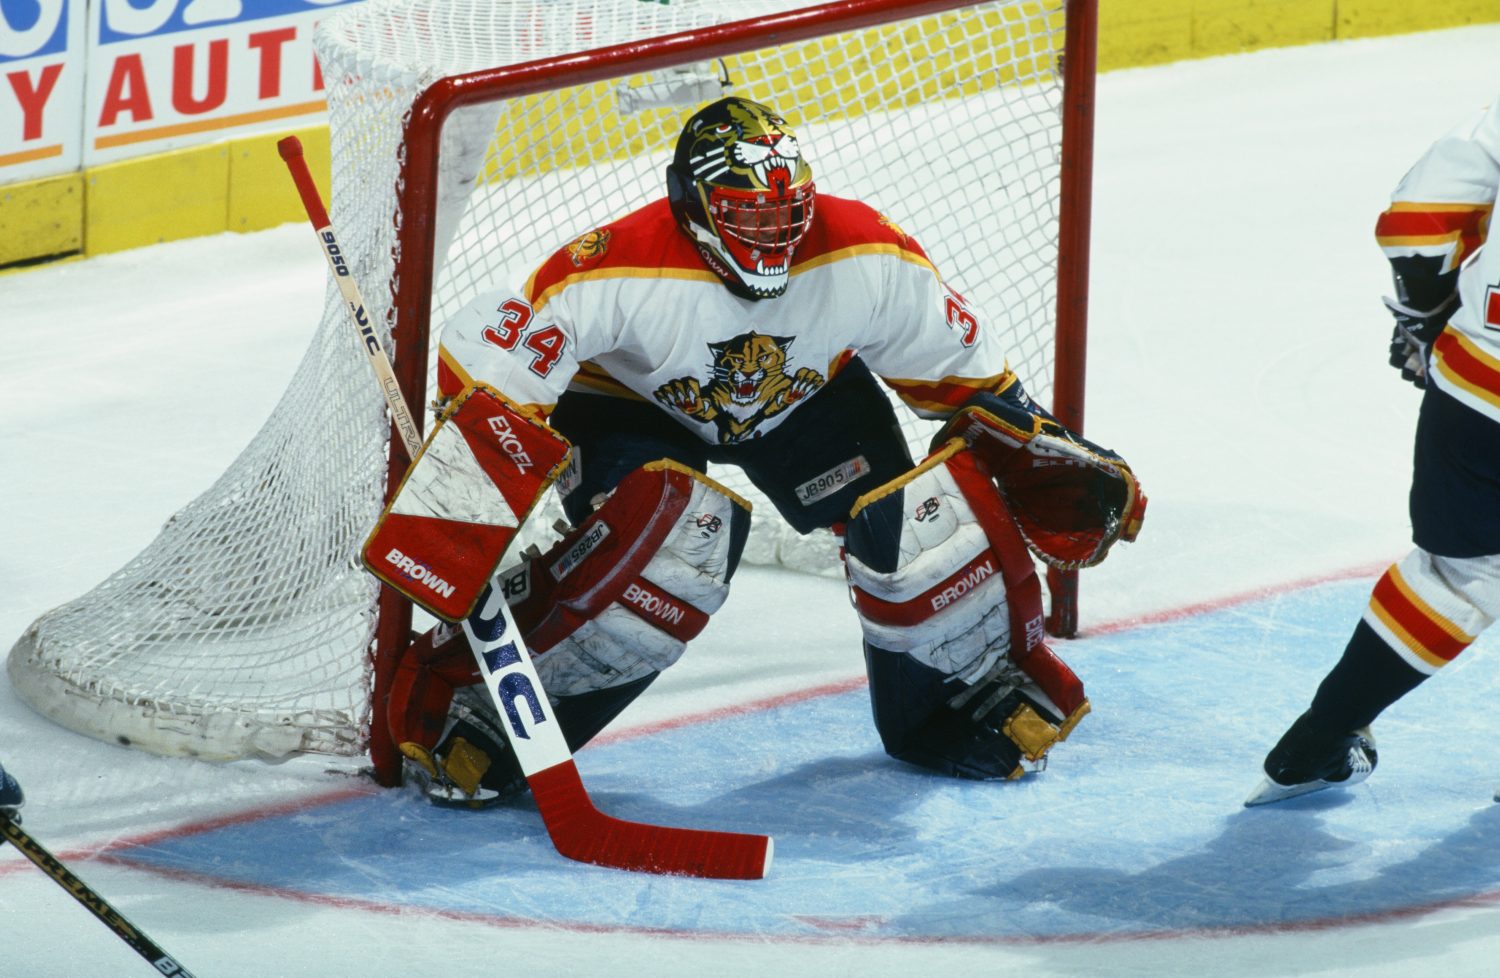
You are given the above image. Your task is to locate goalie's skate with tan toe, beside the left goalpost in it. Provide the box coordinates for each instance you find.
[402,686,527,809]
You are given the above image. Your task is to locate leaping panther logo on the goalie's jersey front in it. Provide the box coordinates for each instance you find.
[654,330,824,446]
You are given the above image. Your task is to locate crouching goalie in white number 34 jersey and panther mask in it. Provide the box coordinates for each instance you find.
[366,98,1146,806]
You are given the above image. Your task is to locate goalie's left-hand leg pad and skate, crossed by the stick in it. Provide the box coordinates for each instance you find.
[389,461,749,806]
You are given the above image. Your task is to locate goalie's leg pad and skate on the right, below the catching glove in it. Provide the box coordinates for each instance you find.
[845,440,1089,779]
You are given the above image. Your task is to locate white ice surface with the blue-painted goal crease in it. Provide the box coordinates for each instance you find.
[0,27,1500,978]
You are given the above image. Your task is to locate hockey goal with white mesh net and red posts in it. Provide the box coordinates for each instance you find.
[9,0,1094,780]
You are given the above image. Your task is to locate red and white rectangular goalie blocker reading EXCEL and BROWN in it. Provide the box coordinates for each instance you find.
[365,384,569,621]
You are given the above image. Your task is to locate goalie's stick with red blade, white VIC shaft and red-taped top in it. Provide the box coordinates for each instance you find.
[276,137,773,879]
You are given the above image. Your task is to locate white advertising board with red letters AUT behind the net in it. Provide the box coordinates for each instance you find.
[85,0,357,165]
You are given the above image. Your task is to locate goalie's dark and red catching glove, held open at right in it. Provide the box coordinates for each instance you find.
[933,378,1146,570]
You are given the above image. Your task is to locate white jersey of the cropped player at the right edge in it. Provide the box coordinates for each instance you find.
[1376,102,1500,423]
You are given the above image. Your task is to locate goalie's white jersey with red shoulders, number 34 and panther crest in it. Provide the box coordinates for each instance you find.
[438,194,1014,444]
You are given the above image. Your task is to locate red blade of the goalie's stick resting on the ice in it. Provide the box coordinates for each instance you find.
[527,761,774,879]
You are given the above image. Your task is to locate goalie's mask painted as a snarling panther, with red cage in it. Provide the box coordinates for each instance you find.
[666,98,815,299]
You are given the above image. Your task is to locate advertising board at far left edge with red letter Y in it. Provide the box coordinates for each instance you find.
[0,0,87,183]
